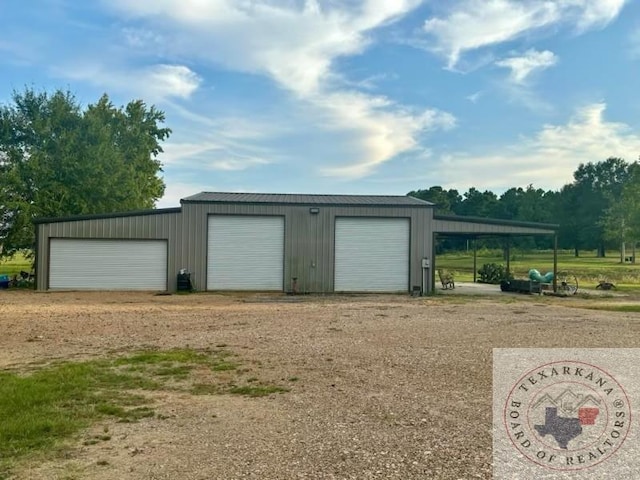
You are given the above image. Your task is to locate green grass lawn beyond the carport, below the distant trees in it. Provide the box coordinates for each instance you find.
[435,249,640,290]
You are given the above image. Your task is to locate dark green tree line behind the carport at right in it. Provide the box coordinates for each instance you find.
[408,157,640,256]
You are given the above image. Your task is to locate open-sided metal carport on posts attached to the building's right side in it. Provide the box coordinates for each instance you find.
[431,214,560,292]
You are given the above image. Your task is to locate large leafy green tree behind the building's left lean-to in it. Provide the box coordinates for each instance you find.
[0,88,171,257]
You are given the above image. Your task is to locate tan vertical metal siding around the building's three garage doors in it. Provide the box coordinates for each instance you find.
[37,203,433,292]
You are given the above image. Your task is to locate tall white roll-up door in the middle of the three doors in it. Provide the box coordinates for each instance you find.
[207,215,284,291]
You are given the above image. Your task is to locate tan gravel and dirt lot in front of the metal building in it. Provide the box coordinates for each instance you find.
[0,291,640,480]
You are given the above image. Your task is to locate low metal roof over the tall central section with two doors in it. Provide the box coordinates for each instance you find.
[180,192,434,207]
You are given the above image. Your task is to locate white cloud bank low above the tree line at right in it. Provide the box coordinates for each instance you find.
[438,103,640,190]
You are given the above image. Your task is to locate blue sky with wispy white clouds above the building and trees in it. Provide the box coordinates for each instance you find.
[0,0,640,207]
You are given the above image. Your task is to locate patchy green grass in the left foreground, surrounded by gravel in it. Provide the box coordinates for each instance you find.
[0,349,288,479]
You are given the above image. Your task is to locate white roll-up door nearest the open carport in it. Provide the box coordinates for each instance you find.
[334,218,409,292]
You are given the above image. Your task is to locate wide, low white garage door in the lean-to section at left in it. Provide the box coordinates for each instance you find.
[49,238,167,290]
